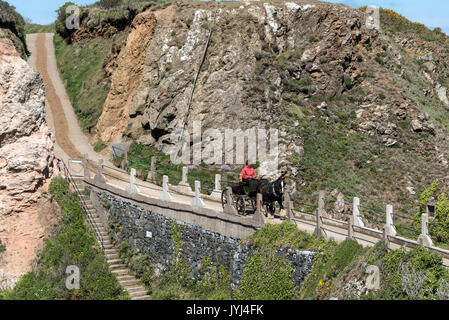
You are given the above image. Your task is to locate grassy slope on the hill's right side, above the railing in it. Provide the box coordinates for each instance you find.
[285,10,449,231]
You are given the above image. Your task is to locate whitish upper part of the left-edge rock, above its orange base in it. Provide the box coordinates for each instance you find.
[0,55,54,212]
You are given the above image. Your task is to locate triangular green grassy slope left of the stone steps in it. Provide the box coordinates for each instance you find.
[0,178,129,300]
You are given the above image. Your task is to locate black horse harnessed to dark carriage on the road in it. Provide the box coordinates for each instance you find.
[221,173,287,216]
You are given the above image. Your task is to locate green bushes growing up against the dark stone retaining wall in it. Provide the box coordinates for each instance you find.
[107,222,318,300]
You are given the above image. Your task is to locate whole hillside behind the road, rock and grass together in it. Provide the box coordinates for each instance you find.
[56,1,449,235]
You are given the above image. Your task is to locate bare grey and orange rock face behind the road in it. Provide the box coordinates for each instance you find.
[93,2,447,161]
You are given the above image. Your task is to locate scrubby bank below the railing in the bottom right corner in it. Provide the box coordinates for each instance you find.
[299,241,449,300]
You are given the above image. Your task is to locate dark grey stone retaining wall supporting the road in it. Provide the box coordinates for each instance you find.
[91,189,315,287]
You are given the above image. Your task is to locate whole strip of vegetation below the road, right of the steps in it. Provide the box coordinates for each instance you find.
[106,218,449,300]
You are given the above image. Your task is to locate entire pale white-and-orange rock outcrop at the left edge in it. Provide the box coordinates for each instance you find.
[0,29,55,289]
